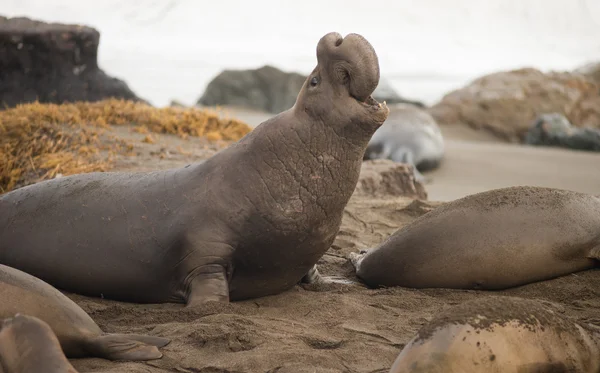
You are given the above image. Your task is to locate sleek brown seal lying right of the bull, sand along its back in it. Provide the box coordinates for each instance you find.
[350,186,600,290]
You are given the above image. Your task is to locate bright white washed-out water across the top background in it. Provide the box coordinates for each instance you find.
[0,0,600,106]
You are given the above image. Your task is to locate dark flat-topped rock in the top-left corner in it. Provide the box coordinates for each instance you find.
[0,16,144,108]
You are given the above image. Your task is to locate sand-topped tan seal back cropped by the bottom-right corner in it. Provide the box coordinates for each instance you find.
[390,296,600,373]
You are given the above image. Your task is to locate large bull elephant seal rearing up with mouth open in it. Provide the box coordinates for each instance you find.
[0,33,389,307]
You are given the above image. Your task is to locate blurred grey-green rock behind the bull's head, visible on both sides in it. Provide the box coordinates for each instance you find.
[197,65,424,114]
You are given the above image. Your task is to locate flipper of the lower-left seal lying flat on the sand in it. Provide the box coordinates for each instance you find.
[87,334,162,361]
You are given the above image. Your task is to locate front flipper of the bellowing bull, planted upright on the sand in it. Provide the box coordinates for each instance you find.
[186,264,229,307]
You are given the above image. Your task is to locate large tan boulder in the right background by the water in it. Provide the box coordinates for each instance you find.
[428,68,600,142]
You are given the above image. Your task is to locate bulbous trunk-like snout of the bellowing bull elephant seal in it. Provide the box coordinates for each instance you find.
[317,32,379,102]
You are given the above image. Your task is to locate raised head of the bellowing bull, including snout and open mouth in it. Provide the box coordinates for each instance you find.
[294,32,389,135]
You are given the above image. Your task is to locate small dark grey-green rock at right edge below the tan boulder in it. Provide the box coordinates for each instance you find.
[525,113,600,151]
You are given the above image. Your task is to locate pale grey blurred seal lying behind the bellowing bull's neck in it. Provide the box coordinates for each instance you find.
[364,104,445,182]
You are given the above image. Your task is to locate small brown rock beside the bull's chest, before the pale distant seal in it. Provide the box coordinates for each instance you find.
[354,159,427,200]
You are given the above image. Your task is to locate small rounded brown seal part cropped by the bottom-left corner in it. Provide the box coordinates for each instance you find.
[0,314,77,373]
